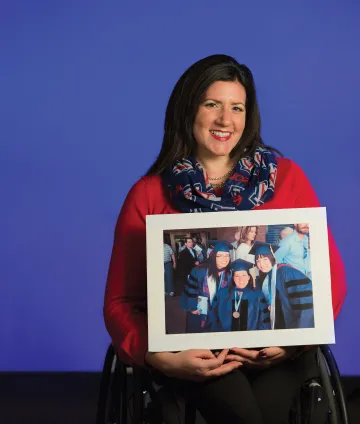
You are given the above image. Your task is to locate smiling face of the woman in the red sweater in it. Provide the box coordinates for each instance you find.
[193,81,246,158]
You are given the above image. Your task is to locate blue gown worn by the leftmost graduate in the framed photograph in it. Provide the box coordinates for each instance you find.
[180,265,231,333]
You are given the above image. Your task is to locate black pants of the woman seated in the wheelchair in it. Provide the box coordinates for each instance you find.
[152,349,319,424]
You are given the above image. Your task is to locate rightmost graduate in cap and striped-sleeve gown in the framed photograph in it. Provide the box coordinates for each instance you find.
[249,241,314,329]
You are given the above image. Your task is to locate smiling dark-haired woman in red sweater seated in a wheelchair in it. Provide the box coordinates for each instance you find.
[104,55,346,424]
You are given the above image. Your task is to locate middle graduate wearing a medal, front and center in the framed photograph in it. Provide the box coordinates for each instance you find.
[207,259,270,332]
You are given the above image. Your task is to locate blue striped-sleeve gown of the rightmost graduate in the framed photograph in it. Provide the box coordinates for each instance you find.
[262,264,314,329]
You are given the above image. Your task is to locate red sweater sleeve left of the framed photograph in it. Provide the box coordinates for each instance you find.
[104,179,148,365]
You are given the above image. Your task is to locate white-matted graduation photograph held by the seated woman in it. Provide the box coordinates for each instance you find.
[146,207,335,352]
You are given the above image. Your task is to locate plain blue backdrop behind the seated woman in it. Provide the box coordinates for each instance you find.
[0,0,360,375]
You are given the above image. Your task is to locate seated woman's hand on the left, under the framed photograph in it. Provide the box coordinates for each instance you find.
[145,349,242,381]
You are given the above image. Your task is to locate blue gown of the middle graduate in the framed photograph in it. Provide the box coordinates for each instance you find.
[206,287,270,332]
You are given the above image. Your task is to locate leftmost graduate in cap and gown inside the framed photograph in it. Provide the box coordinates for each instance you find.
[181,242,232,333]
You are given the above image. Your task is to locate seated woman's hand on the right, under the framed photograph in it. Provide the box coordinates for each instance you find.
[226,346,297,368]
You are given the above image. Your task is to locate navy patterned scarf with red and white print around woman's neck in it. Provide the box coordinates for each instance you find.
[164,147,277,212]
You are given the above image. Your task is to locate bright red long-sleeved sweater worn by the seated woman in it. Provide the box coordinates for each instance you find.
[104,158,346,365]
